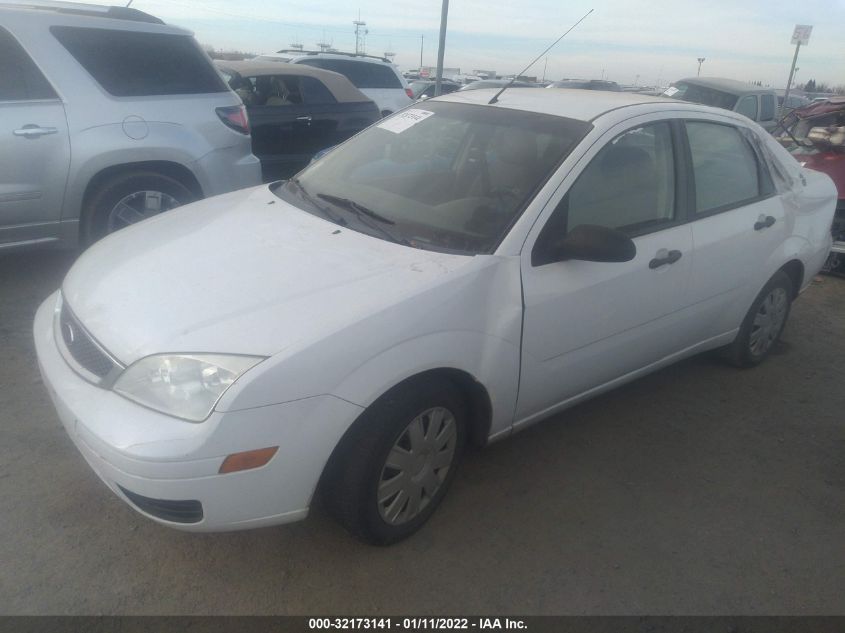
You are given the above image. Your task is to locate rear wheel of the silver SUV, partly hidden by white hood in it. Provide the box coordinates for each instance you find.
[82,171,197,245]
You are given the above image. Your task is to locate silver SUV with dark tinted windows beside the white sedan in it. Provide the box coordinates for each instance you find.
[0,1,261,251]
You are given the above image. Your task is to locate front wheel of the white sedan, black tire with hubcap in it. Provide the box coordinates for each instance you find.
[322,379,467,545]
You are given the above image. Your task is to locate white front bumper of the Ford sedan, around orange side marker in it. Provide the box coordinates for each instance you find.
[34,294,361,532]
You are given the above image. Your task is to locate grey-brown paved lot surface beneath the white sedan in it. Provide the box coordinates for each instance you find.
[0,253,845,614]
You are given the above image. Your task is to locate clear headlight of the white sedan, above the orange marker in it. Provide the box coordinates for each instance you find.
[112,354,264,422]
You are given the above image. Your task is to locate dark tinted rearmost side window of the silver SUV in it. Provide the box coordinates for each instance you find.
[50,26,228,97]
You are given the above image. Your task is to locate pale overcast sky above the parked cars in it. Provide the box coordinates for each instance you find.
[113,0,845,87]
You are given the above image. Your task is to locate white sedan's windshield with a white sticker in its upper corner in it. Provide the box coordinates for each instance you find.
[274,102,592,254]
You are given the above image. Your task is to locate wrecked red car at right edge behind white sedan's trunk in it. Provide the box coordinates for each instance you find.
[775,97,845,274]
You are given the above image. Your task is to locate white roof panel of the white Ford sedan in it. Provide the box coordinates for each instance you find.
[437,88,684,121]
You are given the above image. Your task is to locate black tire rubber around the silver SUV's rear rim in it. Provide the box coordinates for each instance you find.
[83,171,197,244]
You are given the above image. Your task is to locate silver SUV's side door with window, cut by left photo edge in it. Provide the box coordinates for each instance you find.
[0,27,70,248]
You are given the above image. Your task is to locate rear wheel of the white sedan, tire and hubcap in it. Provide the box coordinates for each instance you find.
[725,270,795,367]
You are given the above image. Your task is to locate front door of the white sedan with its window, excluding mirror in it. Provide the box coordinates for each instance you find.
[516,121,693,425]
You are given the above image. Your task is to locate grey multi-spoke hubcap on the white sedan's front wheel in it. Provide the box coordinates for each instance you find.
[377,407,458,525]
